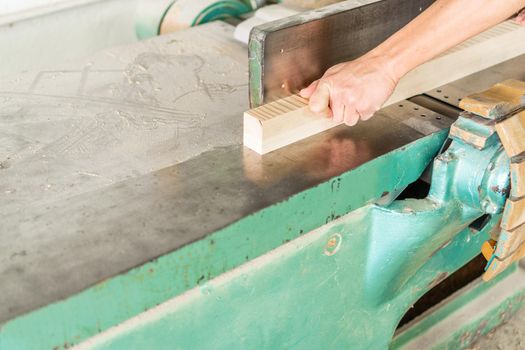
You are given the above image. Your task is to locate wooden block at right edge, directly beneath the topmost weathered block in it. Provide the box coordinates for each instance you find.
[496,111,525,158]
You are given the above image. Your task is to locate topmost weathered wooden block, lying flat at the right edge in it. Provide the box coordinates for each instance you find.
[459,79,525,119]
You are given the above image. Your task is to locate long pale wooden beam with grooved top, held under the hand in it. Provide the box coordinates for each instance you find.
[244,21,525,154]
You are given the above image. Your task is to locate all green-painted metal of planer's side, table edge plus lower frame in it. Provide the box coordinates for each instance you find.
[0,119,509,349]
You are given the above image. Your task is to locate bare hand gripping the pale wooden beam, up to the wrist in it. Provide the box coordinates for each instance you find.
[300,55,399,126]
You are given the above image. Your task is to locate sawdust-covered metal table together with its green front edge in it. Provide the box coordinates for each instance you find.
[0,22,525,349]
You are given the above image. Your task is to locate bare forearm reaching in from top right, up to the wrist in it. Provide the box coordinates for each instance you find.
[366,0,525,79]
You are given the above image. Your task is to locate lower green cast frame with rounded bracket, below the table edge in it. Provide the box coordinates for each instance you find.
[68,124,509,349]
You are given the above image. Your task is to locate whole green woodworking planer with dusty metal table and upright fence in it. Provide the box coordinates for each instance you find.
[0,0,525,350]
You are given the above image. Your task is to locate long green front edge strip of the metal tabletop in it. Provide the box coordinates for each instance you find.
[0,131,446,350]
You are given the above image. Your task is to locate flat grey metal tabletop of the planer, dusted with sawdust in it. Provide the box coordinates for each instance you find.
[0,22,525,322]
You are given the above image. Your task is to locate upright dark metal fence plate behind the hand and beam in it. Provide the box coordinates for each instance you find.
[249,0,434,107]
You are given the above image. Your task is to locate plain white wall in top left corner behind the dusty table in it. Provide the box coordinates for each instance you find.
[0,0,137,77]
